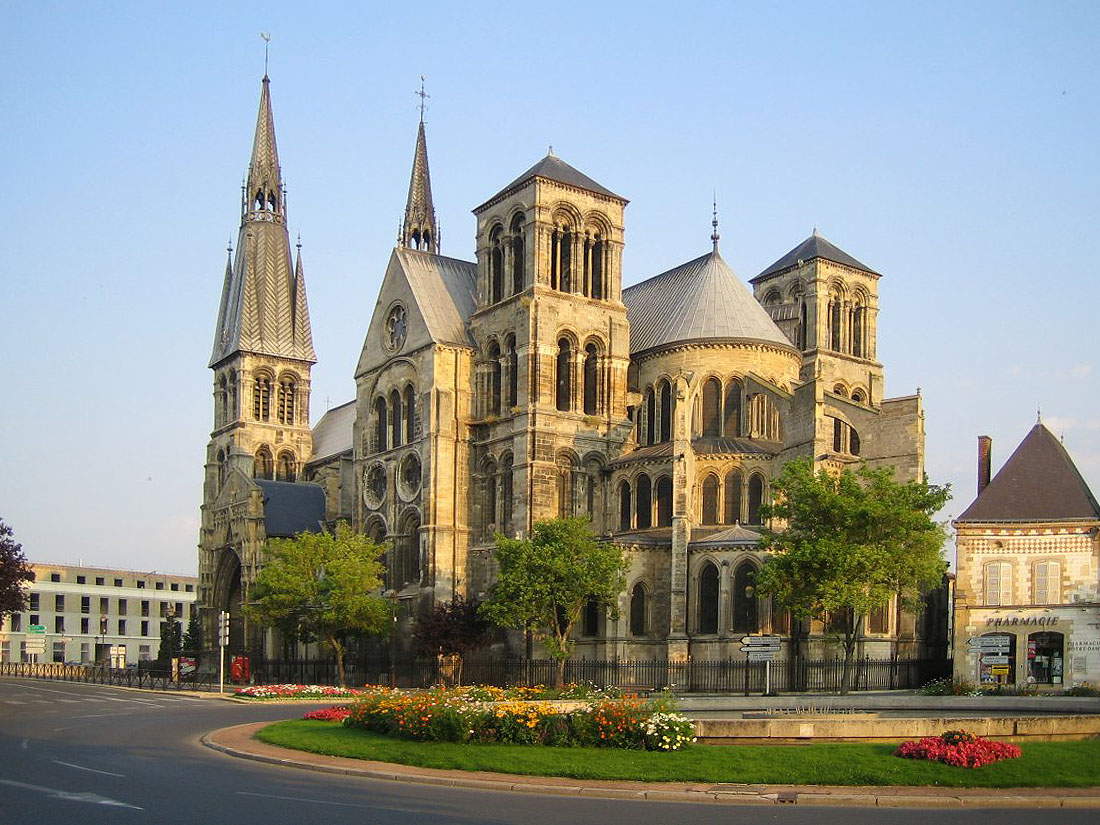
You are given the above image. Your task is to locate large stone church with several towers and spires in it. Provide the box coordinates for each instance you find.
[199,77,942,659]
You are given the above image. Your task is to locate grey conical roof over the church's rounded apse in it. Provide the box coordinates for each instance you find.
[623,250,792,354]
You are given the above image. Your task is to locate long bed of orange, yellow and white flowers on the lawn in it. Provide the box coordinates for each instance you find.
[343,688,694,750]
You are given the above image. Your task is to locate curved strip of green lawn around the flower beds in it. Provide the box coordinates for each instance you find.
[256,721,1100,788]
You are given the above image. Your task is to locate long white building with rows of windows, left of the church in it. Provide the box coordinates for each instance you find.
[0,562,198,666]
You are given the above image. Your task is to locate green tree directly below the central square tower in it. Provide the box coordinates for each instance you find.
[482,518,628,684]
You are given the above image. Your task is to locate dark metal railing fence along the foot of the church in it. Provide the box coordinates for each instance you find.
[245,656,952,693]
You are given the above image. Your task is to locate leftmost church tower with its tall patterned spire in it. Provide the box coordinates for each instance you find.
[199,75,317,651]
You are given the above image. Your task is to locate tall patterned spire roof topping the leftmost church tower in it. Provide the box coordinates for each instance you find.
[210,75,317,366]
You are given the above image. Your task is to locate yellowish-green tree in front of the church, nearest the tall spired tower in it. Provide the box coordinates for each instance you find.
[245,523,391,686]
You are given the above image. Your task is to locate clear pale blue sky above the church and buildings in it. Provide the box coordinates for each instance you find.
[0,0,1100,572]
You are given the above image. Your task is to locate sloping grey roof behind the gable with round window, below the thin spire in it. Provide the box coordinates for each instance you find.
[394,248,477,347]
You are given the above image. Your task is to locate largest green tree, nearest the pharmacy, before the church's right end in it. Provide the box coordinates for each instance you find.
[755,460,950,693]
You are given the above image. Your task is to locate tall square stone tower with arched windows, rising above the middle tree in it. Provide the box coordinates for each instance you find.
[471,152,629,542]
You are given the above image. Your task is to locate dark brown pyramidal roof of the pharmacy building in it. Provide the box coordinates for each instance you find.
[956,424,1100,521]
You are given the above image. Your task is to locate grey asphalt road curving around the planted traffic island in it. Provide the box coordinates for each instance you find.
[0,679,1096,825]
